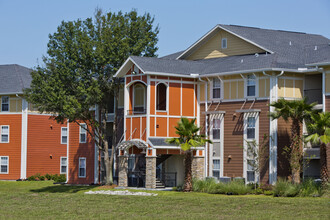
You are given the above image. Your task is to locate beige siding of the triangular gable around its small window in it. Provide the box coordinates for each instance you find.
[186,30,265,60]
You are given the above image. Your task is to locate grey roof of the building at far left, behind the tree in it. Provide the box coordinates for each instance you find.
[0,64,32,94]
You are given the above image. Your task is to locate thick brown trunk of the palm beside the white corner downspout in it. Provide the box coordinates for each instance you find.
[290,120,303,184]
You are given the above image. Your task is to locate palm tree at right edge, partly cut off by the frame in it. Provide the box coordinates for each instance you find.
[306,112,330,184]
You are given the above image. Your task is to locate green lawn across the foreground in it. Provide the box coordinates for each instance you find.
[0,181,330,219]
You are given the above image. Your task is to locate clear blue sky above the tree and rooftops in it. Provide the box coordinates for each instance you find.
[0,0,330,67]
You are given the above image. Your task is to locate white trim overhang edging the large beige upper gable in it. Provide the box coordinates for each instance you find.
[176,24,274,60]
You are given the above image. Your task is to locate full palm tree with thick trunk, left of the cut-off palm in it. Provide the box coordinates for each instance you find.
[270,98,315,183]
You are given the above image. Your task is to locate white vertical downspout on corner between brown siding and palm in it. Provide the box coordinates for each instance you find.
[263,71,284,184]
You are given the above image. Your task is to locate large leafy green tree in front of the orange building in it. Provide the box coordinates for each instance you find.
[25,9,159,184]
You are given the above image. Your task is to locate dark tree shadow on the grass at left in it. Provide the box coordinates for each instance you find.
[30,185,99,193]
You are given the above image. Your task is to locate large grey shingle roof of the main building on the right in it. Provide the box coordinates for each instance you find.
[131,24,330,75]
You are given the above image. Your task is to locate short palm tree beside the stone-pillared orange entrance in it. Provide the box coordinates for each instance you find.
[166,118,212,192]
